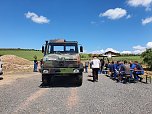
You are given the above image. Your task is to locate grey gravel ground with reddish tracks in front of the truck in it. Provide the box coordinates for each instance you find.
[0,73,152,114]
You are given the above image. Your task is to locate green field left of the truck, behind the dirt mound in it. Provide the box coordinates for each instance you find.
[0,49,43,61]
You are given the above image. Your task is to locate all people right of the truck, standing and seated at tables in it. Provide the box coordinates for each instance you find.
[84,56,144,83]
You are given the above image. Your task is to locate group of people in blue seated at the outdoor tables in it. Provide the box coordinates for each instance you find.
[107,60,144,83]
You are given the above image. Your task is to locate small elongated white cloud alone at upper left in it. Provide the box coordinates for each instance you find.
[25,12,50,24]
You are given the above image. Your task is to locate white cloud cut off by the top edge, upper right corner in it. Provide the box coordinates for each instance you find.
[128,0,152,7]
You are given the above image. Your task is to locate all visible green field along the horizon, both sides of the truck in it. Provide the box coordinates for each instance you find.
[0,49,142,63]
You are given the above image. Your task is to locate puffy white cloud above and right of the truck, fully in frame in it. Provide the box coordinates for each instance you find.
[99,8,127,20]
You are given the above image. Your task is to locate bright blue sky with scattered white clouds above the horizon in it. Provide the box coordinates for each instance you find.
[0,0,152,53]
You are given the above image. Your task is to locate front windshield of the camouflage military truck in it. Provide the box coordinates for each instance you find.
[48,44,78,53]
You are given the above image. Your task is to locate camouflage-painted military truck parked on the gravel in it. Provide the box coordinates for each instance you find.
[41,39,83,86]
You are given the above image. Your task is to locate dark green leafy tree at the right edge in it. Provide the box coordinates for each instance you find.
[141,48,152,70]
